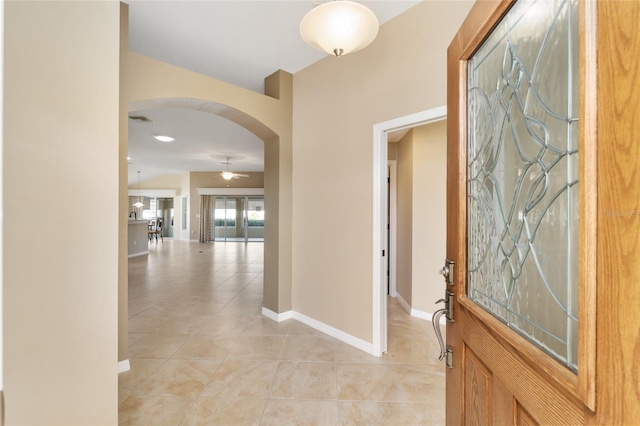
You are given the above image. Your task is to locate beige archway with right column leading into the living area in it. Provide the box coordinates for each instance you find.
[118,47,293,361]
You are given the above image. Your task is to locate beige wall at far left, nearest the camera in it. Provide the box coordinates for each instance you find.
[2,2,120,425]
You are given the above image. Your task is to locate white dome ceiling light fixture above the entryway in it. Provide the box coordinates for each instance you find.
[300,0,379,57]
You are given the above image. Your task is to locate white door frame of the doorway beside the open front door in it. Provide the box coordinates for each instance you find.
[372,105,447,356]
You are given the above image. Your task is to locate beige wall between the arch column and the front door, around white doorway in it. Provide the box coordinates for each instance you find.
[293,1,472,342]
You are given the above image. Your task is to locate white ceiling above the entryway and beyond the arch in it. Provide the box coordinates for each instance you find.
[127,0,418,185]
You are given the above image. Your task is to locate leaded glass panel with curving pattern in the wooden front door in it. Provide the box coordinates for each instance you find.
[467,0,578,371]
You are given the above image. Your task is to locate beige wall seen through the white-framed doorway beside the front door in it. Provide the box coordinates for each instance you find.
[396,121,447,315]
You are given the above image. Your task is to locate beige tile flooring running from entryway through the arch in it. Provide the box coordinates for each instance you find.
[119,239,445,425]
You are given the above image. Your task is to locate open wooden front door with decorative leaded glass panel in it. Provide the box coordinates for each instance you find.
[446,0,640,425]
